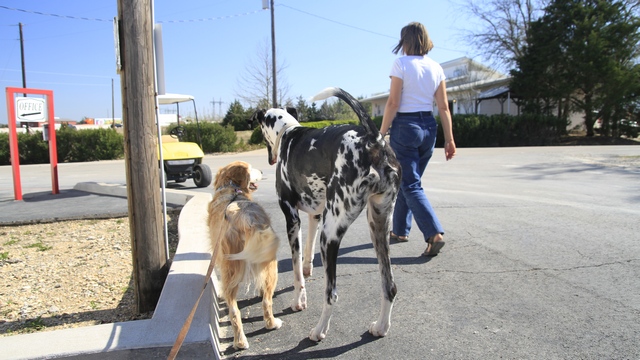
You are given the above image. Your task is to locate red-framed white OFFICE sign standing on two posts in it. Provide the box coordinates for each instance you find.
[6,87,60,200]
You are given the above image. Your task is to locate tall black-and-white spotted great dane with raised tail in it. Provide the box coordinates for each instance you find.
[251,88,401,341]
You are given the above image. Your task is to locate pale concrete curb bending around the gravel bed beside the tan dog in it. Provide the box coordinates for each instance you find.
[0,183,225,359]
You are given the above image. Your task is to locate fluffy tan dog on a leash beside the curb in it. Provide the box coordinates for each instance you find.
[209,161,282,349]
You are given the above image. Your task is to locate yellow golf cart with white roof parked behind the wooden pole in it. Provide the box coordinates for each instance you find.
[158,94,213,187]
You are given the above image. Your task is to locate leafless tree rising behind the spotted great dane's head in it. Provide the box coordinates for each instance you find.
[236,40,290,109]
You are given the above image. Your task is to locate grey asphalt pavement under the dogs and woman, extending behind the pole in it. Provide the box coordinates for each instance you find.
[0,146,640,359]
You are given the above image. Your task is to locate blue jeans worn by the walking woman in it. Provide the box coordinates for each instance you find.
[390,114,444,241]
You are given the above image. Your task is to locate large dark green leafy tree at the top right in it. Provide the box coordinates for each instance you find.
[512,0,640,136]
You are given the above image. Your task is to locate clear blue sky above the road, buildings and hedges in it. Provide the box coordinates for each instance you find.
[0,0,481,123]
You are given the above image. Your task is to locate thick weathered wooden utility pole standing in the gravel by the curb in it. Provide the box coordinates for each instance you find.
[118,0,168,313]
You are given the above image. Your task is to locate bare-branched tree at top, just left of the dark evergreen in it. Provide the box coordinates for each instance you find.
[459,0,550,69]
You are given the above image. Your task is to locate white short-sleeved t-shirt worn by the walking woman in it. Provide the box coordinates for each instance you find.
[391,55,445,112]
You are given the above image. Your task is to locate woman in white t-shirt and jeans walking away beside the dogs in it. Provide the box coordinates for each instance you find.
[380,22,456,256]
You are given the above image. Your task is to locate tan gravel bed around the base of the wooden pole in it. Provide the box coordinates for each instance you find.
[0,211,179,336]
